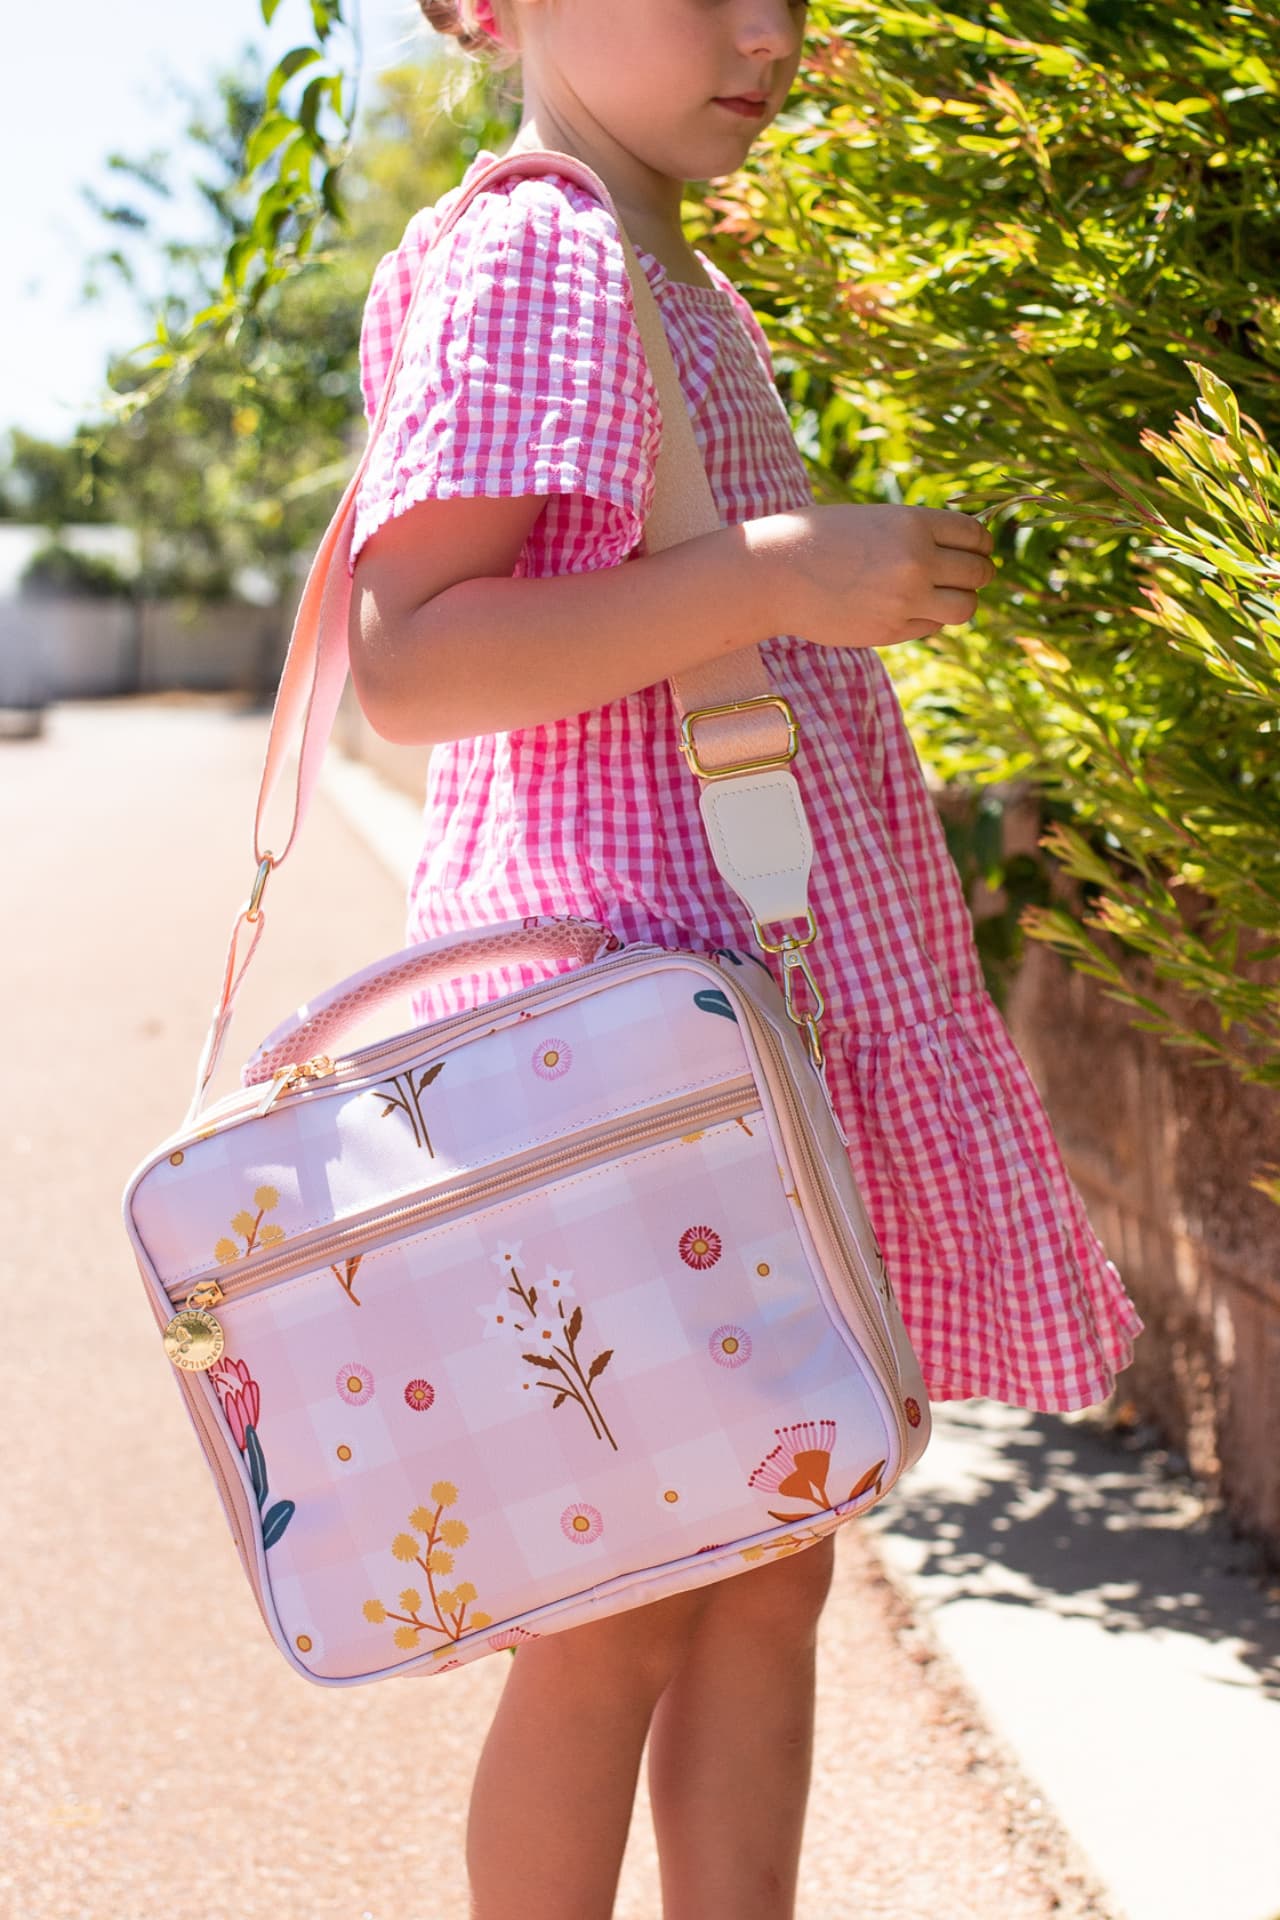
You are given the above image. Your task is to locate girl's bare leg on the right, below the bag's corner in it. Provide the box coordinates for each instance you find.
[649,1534,835,1920]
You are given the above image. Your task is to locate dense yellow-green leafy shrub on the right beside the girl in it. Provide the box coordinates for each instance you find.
[702,0,1280,1167]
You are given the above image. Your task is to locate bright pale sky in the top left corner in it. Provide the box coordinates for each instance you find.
[0,0,428,440]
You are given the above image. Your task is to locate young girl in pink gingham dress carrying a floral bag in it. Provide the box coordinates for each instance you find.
[351,0,1142,1920]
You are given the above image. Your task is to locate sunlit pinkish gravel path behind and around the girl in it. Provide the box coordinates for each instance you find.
[0,701,1119,1920]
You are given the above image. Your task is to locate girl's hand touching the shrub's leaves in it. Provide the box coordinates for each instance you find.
[747,507,996,647]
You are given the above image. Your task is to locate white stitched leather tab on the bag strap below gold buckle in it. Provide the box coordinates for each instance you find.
[699,766,814,924]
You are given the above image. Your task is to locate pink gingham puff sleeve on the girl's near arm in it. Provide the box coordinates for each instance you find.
[351,175,660,564]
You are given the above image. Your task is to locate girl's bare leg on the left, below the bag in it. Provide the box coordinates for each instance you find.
[466,1590,710,1920]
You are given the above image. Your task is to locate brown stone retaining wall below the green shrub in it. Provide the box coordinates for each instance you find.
[1009,945,1280,1563]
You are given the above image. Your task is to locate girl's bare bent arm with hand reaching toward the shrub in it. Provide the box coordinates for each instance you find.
[349,495,994,745]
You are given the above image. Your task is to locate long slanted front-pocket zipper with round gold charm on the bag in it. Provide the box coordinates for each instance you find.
[165,1073,760,1328]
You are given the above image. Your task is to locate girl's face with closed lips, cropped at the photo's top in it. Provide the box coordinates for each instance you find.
[518,0,806,180]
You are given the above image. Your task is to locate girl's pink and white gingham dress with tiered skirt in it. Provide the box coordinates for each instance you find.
[353,152,1142,1409]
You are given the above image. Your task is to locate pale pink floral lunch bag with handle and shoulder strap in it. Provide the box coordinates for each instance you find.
[125,150,929,1686]
